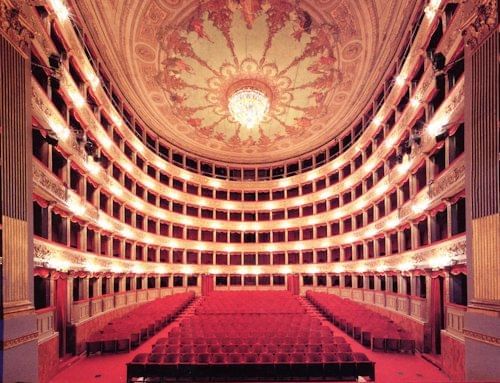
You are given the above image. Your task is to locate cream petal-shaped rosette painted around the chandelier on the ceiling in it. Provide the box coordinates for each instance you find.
[156,0,342,154]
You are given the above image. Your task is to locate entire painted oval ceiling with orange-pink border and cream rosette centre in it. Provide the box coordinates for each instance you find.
[75,0,414,164]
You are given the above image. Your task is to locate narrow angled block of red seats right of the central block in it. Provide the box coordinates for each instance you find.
[306,291,415,353]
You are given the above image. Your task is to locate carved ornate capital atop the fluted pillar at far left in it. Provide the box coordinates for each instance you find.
[0,2,35,54]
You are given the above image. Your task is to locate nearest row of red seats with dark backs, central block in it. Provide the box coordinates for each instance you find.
[127,353,375,382]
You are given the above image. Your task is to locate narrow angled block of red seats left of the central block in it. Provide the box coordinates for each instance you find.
[87,292,195,355]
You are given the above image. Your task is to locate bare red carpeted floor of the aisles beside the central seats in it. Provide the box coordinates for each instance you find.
[51,300,450,383]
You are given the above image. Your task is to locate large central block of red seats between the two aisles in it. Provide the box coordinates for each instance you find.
[127,292,375,382]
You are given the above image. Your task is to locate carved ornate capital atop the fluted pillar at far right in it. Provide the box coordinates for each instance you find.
[462,0,498,49]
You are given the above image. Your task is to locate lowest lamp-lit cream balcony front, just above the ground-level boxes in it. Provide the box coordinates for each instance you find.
[33,236,466,275]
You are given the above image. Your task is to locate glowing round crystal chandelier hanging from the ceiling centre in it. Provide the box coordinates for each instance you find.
[228,88,269,129]
